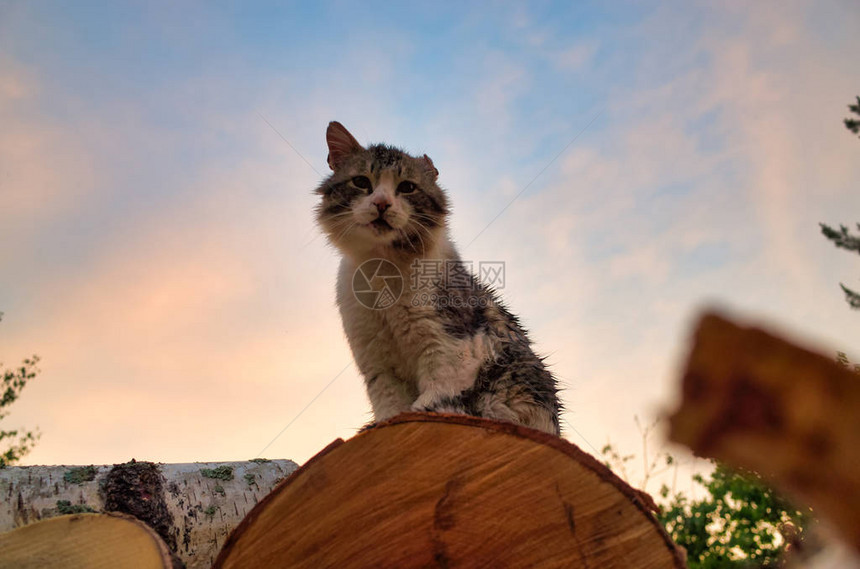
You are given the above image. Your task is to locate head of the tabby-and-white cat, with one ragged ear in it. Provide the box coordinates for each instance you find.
[316,122,448,259]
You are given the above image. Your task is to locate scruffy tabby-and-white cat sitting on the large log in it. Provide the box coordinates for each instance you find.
[316,118,561,435]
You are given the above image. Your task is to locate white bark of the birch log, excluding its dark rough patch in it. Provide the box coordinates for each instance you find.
[0,460,297,569]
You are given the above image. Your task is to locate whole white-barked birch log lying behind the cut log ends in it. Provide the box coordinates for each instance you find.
[0,460,297,569]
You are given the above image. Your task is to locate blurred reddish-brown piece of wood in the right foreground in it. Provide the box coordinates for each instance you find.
[669,314,860,550]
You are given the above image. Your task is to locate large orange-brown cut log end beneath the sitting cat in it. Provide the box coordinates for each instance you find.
[215,414,684,569]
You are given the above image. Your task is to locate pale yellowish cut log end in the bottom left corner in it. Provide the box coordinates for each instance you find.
[0,514,174,569]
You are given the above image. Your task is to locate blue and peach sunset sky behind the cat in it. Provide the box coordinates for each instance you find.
[0,0,860,488]
